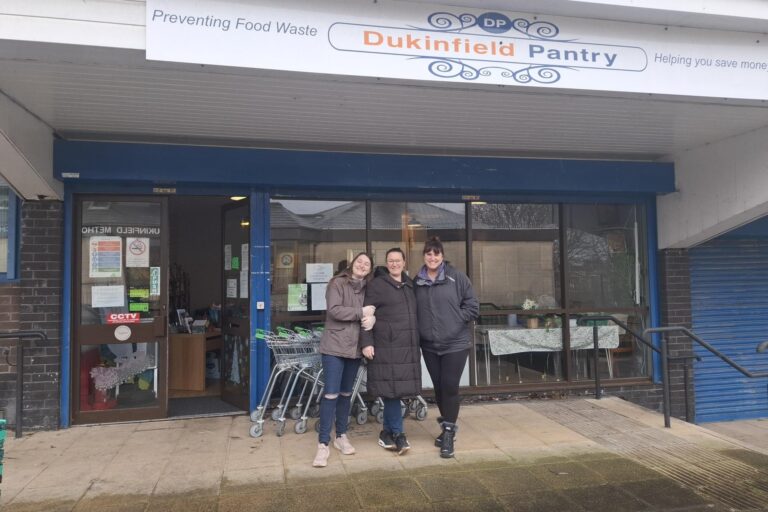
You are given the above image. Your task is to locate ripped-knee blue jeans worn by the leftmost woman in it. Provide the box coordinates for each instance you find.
[318,354,360,444]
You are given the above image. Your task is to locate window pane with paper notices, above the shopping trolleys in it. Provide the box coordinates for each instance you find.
[270,199,365,329]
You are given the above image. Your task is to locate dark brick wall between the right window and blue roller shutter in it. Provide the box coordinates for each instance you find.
[611,249,694,419]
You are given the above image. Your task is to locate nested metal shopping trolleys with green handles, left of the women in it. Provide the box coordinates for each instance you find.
[250,327,322,437]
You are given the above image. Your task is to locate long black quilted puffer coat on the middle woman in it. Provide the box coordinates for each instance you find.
[360,274,421,398]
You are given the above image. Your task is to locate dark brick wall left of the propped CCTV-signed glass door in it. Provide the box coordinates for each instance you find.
[12,201,64,430]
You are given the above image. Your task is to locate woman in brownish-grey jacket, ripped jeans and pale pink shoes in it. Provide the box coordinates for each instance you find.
[312,253,376,468]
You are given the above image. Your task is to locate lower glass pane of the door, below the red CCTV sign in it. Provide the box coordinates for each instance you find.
[80,342,159,411]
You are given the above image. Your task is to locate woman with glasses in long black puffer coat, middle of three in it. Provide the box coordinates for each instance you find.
[361,248,421,455]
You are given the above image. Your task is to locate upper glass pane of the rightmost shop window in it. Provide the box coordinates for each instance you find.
[566,204,644,308]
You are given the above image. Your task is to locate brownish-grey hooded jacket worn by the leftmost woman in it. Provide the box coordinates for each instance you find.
[320,271,366,359]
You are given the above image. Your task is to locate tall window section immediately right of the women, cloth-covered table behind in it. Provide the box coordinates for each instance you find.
[472,204,563,385]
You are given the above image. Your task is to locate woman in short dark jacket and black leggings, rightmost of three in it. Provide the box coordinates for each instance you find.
[414,237,480,458]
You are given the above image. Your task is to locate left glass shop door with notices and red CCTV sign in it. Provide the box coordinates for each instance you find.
[72,196,168,423]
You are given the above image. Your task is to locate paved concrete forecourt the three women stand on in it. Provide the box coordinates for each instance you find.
[0,398,768,512]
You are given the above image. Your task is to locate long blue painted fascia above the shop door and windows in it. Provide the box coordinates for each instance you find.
[54,140,674,195]
